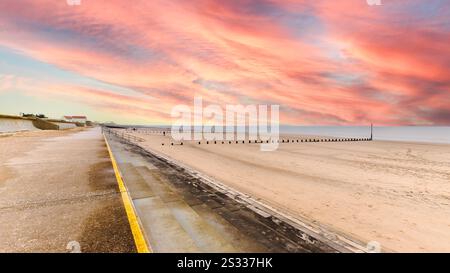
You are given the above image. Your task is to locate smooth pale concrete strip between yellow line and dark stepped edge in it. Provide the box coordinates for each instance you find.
[108,137,269,253]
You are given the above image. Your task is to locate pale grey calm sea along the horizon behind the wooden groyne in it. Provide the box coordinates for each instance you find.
[280,126,450,144]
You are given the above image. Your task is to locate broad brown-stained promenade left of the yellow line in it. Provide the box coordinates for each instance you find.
[0,128,136,252]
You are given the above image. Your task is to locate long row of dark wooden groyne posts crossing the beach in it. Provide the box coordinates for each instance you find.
[161,138,372,146]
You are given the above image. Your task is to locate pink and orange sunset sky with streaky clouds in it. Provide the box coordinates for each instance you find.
[0,0,450,125]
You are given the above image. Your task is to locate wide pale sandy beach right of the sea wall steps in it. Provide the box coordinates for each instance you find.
[126,133,450,252]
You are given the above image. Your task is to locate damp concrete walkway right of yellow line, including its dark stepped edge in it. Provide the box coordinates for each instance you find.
[109,136,338,252]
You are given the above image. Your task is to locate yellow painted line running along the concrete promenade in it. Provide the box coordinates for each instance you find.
[103,135,151,253]
